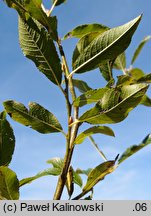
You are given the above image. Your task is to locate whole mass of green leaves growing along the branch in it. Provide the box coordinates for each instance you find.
[0,0,151,199]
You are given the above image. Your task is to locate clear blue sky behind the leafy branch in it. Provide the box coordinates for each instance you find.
[0,0,151,200]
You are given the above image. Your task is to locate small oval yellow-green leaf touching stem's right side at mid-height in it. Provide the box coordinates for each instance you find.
[73,88,108,107]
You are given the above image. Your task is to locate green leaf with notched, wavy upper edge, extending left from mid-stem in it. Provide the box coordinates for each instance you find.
[3,100,62,134]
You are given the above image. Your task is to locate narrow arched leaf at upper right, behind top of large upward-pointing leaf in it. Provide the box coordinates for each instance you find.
[64,23,109,39]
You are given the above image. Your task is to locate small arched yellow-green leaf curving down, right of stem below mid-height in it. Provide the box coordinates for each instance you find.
[75,126,114,144]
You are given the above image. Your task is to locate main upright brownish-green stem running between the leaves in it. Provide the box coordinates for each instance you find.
[53,40,79,200]
